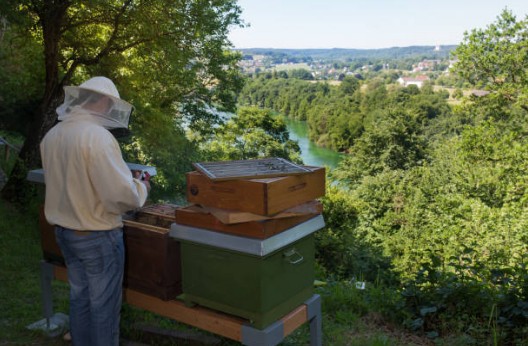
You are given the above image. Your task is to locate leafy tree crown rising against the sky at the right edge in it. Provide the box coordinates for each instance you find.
[454,9,528,118]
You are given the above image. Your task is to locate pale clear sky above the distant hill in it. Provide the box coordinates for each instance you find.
[229,0,528,48]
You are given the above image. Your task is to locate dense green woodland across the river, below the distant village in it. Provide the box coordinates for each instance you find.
[239,73,451,152]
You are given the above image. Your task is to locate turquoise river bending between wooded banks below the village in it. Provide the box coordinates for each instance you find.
[282,116,343,168]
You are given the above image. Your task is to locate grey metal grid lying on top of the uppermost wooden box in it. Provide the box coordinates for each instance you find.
[193,157,312,181]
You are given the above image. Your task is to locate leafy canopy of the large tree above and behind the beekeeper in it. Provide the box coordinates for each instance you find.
[0,0,243,199]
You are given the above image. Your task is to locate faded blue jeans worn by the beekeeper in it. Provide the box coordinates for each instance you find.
[55,226,125,346]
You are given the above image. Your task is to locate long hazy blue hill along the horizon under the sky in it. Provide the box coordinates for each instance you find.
[235,45,457,61]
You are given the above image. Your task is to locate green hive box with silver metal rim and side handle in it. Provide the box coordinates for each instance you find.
[171,215,324,329]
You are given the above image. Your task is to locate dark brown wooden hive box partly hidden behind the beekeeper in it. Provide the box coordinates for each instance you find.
[40,205,181,300]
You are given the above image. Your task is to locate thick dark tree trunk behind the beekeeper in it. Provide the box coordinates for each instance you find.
[2,0,70,204]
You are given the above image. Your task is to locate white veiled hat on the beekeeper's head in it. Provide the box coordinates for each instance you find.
[57,77,133,129]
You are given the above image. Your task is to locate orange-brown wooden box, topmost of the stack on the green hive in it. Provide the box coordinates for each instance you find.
[186,167,325,215]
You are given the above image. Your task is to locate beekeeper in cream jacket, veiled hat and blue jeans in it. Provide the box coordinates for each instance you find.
[40,77,150,346]
